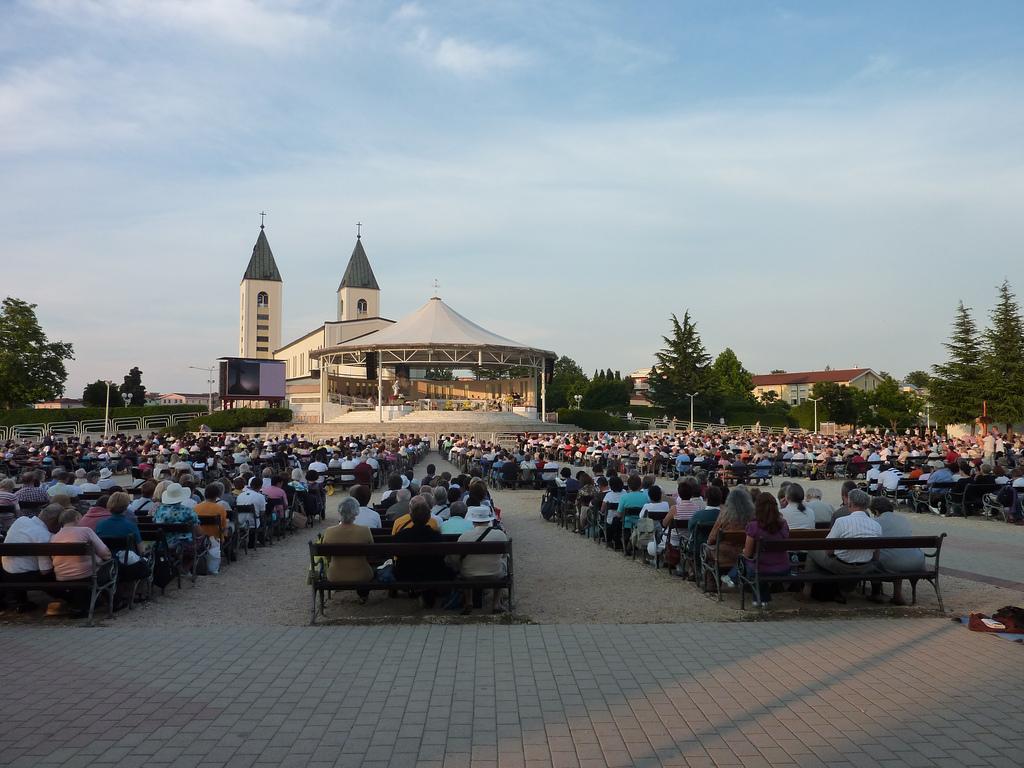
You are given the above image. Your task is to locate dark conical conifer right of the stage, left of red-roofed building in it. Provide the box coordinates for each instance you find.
[648,310,718,417]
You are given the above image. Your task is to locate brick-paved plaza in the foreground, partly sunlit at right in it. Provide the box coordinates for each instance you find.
[0,618,1024,768]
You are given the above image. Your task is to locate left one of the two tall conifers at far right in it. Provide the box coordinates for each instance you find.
[929,301,984,433]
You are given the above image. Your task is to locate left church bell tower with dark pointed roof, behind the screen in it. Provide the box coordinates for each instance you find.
[239,224,284,359]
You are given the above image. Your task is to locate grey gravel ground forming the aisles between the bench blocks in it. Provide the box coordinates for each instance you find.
[0,454,1020,627]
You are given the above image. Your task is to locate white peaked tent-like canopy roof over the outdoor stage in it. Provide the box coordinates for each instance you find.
[335,297,542,351]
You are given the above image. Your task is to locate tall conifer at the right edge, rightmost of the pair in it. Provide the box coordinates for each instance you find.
[982,281,1024,431]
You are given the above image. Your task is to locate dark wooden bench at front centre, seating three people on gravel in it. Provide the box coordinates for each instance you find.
[309,541,513,625]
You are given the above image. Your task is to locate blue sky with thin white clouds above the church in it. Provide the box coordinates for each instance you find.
[0,0,1024,396]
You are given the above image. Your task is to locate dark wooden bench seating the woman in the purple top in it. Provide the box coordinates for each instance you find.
[738,534,946,613]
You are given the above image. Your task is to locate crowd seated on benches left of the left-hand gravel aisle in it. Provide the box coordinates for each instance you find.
[0,433,428,615]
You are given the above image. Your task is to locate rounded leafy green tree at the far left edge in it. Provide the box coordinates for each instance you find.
[0,297,75,409]
